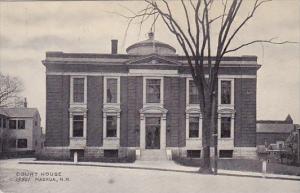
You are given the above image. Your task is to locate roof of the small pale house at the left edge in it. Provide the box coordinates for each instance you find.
[0,107,39,118]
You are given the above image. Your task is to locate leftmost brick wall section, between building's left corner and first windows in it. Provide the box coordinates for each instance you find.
[45,75,70,146]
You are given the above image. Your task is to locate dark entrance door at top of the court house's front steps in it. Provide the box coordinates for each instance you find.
[145,117,160,149]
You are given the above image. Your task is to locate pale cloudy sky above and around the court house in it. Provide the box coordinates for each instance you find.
[0,0,300,126]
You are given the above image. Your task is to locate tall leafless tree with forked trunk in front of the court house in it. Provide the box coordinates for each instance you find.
[122,0,294,173]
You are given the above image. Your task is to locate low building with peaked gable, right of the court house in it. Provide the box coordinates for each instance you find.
[256,115,295,149]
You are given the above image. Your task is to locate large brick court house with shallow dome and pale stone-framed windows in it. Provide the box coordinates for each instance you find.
[43,33,260,160]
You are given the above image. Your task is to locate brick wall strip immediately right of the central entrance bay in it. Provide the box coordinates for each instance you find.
[164,77,185,147]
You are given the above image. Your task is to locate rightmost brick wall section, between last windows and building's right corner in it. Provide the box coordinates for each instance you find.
[234,78,256,147]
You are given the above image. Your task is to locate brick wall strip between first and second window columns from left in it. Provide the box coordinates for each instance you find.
[87,76,103,146]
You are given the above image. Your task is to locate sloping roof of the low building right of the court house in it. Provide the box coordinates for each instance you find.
[256,122,294,133]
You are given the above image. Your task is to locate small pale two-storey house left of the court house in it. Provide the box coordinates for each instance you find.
[0,104,43,156]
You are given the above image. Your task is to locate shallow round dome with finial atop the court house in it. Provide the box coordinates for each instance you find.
[126,32,176,55]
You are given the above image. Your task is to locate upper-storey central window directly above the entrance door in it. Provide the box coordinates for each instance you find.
[146,79,160,103]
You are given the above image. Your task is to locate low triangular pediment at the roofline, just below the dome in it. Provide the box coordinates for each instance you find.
[126,54,181,65]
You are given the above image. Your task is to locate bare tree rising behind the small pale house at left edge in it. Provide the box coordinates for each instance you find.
[0,72,23,107]
